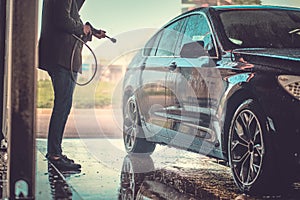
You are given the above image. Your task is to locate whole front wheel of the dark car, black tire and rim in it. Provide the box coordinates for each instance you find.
[228,99,288,195]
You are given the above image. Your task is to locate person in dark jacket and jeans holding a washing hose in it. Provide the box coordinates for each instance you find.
[39,0,105,170]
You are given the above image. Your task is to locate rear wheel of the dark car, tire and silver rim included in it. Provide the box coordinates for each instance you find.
[123,95,156,154]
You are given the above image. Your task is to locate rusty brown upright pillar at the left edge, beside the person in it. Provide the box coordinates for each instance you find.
[8,0,38,199]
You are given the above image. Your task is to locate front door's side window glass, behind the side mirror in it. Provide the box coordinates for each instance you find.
[180,14,217,57]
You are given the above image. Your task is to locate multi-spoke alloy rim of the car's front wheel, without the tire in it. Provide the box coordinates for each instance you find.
[229,109,265,188]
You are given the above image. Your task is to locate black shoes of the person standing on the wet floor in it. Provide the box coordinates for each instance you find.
[47,156,81,171]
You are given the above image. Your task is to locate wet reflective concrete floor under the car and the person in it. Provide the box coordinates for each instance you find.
[36,138,300,200]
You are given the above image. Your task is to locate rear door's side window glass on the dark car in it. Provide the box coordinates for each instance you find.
[155,19,184,56]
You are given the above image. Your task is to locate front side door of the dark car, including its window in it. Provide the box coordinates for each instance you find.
[169,14,223,153]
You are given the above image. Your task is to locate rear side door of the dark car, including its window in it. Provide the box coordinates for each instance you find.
[140,18,183,142]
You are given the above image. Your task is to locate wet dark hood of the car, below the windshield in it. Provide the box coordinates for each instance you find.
[232,48,300,73]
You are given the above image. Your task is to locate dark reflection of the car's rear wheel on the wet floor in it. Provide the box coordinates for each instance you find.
[119,155,195,200]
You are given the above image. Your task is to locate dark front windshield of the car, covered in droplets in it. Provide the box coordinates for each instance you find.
[219,9,300,49]
